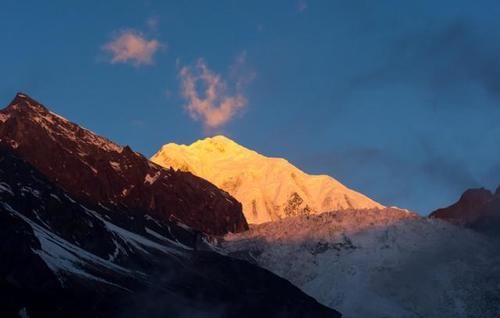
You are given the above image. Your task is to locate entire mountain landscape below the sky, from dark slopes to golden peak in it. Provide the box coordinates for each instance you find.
[0,93,500,318]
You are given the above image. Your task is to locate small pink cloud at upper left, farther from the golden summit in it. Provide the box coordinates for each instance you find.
[103,30,164,66]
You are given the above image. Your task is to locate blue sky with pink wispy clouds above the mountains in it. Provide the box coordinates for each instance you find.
[0,0,500,214]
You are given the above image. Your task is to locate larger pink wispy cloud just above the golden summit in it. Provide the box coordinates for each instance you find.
[179,52,253,130]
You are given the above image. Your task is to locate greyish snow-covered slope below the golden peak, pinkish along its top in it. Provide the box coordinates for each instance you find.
[222,209,500,318]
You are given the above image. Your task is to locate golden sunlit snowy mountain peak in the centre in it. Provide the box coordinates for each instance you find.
[151,136,382,224]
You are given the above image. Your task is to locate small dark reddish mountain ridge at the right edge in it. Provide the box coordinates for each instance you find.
[429,186,500,235]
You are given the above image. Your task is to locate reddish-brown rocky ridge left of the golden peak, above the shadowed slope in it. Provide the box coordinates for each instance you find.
[0,93,248,234]
